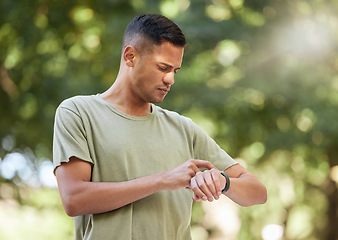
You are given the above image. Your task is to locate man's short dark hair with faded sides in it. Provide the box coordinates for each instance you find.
[123,14,186,52]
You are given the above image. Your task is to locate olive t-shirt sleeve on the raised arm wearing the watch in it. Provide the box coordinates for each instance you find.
[192,122,237,170]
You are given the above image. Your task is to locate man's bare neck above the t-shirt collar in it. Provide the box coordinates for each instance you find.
[100,77,151,117]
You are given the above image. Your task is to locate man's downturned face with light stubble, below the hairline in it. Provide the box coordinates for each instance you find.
[131,42,184,103]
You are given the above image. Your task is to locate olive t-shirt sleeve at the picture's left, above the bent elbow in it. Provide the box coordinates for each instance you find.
[53,102,93,172]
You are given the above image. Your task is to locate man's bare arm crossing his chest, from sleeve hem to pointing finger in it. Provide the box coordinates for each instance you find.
[55,157,214,217]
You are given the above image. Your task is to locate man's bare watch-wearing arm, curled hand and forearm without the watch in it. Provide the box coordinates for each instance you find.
[190,164,267,206]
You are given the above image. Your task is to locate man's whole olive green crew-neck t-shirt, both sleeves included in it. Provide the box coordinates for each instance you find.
[53,95,236,240]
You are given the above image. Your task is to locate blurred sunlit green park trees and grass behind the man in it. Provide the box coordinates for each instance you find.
[0,0,338,240]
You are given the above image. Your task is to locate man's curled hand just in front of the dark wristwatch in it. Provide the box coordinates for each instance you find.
[190,168,226,202]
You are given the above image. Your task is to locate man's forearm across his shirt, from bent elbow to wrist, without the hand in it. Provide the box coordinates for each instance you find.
[60,173,168,216]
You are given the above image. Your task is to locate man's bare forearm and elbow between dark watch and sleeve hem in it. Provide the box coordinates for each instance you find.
[225,172,267,207]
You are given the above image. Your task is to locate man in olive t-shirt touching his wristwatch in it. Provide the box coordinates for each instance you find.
[53,14,267,240]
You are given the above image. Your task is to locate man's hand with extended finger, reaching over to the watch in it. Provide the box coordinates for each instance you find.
[163,159,215,190]
